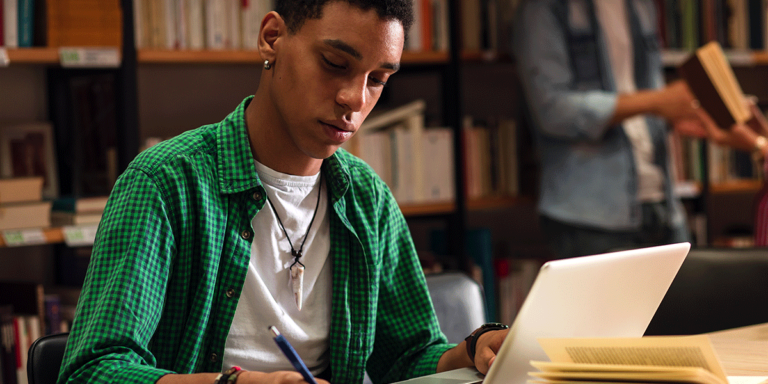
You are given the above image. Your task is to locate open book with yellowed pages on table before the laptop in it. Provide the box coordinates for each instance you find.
[529,335,768,384]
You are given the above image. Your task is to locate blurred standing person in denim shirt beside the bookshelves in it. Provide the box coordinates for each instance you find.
[512,0,700,258]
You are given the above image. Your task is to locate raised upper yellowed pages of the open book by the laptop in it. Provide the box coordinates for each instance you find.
[539,335,728,383]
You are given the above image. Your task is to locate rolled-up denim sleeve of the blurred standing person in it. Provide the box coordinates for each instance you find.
[512,0,617,140]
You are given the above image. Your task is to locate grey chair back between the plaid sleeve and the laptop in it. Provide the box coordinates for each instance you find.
[426,272,486,344]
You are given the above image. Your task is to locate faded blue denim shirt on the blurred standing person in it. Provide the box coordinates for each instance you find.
[513,0,685,230]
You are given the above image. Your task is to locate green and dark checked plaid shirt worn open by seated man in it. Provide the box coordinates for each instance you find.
[59,97,453,383]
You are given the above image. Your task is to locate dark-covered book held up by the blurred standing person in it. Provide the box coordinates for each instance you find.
[679,41,752,128]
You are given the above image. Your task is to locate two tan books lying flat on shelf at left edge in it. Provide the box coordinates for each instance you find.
[0,177,51,230]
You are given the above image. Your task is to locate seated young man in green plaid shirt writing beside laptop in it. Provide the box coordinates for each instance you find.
[59,0,506,384]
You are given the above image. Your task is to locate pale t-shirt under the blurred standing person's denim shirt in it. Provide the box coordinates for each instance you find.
[595,0,664,202]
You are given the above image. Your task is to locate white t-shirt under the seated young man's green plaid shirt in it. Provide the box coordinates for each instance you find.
[223,162,332,375]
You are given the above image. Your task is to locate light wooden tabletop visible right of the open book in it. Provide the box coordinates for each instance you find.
[708,323,768,376]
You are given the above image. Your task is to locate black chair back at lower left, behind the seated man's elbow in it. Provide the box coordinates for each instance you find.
[27,333,69,384]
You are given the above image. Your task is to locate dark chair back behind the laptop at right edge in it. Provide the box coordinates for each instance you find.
[645,248,768,335]
